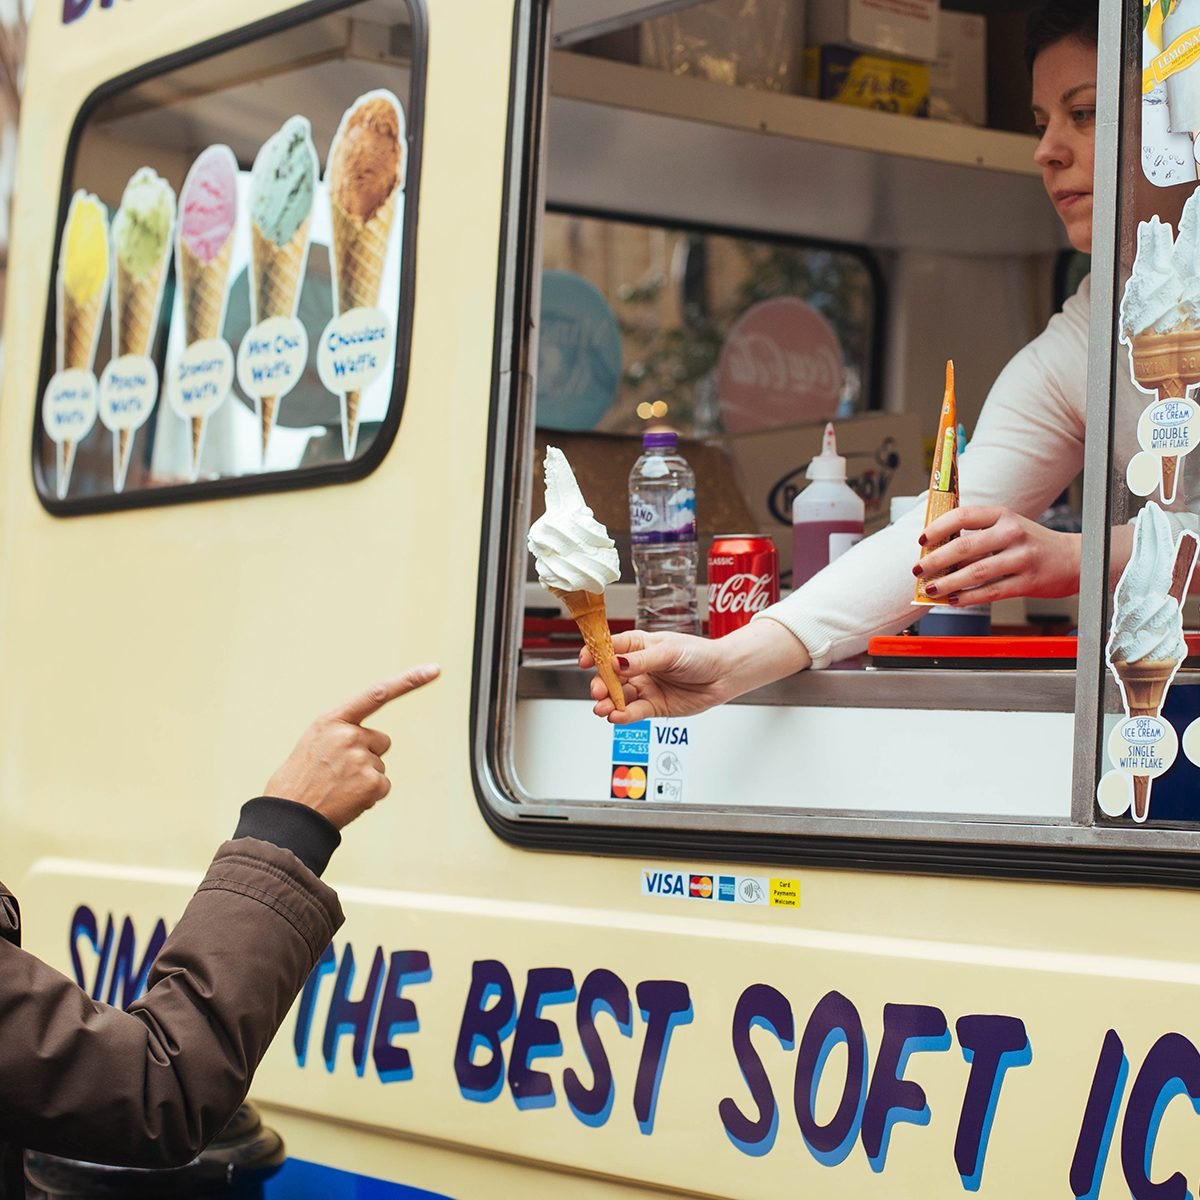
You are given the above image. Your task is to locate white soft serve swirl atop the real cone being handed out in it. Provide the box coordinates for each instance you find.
[529,446,620,593]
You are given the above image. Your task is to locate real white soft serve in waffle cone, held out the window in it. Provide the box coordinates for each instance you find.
[529,446,625,712]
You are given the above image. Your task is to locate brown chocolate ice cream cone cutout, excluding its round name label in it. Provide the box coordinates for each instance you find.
[326,90,407,458]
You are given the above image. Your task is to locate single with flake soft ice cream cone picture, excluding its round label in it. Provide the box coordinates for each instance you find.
[1106,502,1196,821]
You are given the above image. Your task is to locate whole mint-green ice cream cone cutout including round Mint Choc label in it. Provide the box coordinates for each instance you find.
[246,116,319,466]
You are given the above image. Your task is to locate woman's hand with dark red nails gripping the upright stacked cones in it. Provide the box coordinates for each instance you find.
[912,508,1080,605]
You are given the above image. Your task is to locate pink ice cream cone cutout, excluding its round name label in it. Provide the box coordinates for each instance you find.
[175,145,238,479]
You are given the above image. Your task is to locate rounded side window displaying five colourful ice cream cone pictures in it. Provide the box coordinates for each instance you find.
[34,0,425,514]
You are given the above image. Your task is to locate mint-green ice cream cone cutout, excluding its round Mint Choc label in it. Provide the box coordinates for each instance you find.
[239,116,318,466]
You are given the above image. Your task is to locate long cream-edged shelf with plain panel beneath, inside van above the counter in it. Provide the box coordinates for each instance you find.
[546,50,1066,256]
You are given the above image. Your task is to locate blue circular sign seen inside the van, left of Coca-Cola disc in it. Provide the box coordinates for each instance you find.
[538,271,620,433]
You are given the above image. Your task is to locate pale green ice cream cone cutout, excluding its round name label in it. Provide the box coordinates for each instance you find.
[113,167,175,491]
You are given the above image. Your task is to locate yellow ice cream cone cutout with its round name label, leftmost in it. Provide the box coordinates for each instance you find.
[42,191,110,500]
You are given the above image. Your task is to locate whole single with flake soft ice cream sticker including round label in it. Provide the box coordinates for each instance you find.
[1105,502,1200,823]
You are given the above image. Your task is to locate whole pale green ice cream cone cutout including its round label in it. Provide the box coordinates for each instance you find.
[100,167,175,492]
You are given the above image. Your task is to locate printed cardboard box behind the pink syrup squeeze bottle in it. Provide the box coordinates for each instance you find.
[697,413,929,590]
